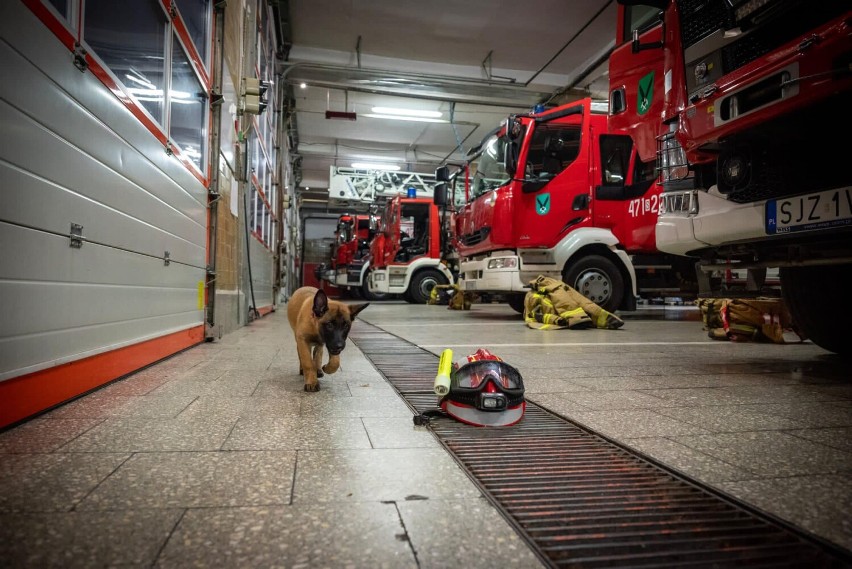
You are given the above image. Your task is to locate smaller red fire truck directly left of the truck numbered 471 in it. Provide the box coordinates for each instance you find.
[368,195,456,304]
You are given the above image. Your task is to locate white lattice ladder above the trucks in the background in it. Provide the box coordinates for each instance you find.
[328,166,435,211]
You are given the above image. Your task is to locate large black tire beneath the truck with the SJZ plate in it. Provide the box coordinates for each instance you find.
[778,264,852,357]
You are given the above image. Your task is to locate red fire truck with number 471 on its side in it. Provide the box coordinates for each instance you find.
[446,98,694,312]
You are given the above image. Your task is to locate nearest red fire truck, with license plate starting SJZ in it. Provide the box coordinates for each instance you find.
[610,0,852,354]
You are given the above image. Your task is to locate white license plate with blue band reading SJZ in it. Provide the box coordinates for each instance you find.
[766,188,852,235]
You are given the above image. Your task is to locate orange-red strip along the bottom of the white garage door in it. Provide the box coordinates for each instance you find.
[0,326,204,428]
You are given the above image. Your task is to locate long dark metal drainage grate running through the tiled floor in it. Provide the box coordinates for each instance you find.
[349,322,852,568]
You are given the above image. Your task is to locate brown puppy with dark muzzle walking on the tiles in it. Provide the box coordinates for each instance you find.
[287,286,370,391]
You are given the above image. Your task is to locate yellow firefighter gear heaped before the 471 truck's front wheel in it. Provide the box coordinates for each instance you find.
[524,275,624,330]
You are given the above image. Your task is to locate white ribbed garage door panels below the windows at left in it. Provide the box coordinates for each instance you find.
[0,1,207,380]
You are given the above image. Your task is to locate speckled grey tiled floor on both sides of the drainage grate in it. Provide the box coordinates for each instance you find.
[0,302,852,568]
